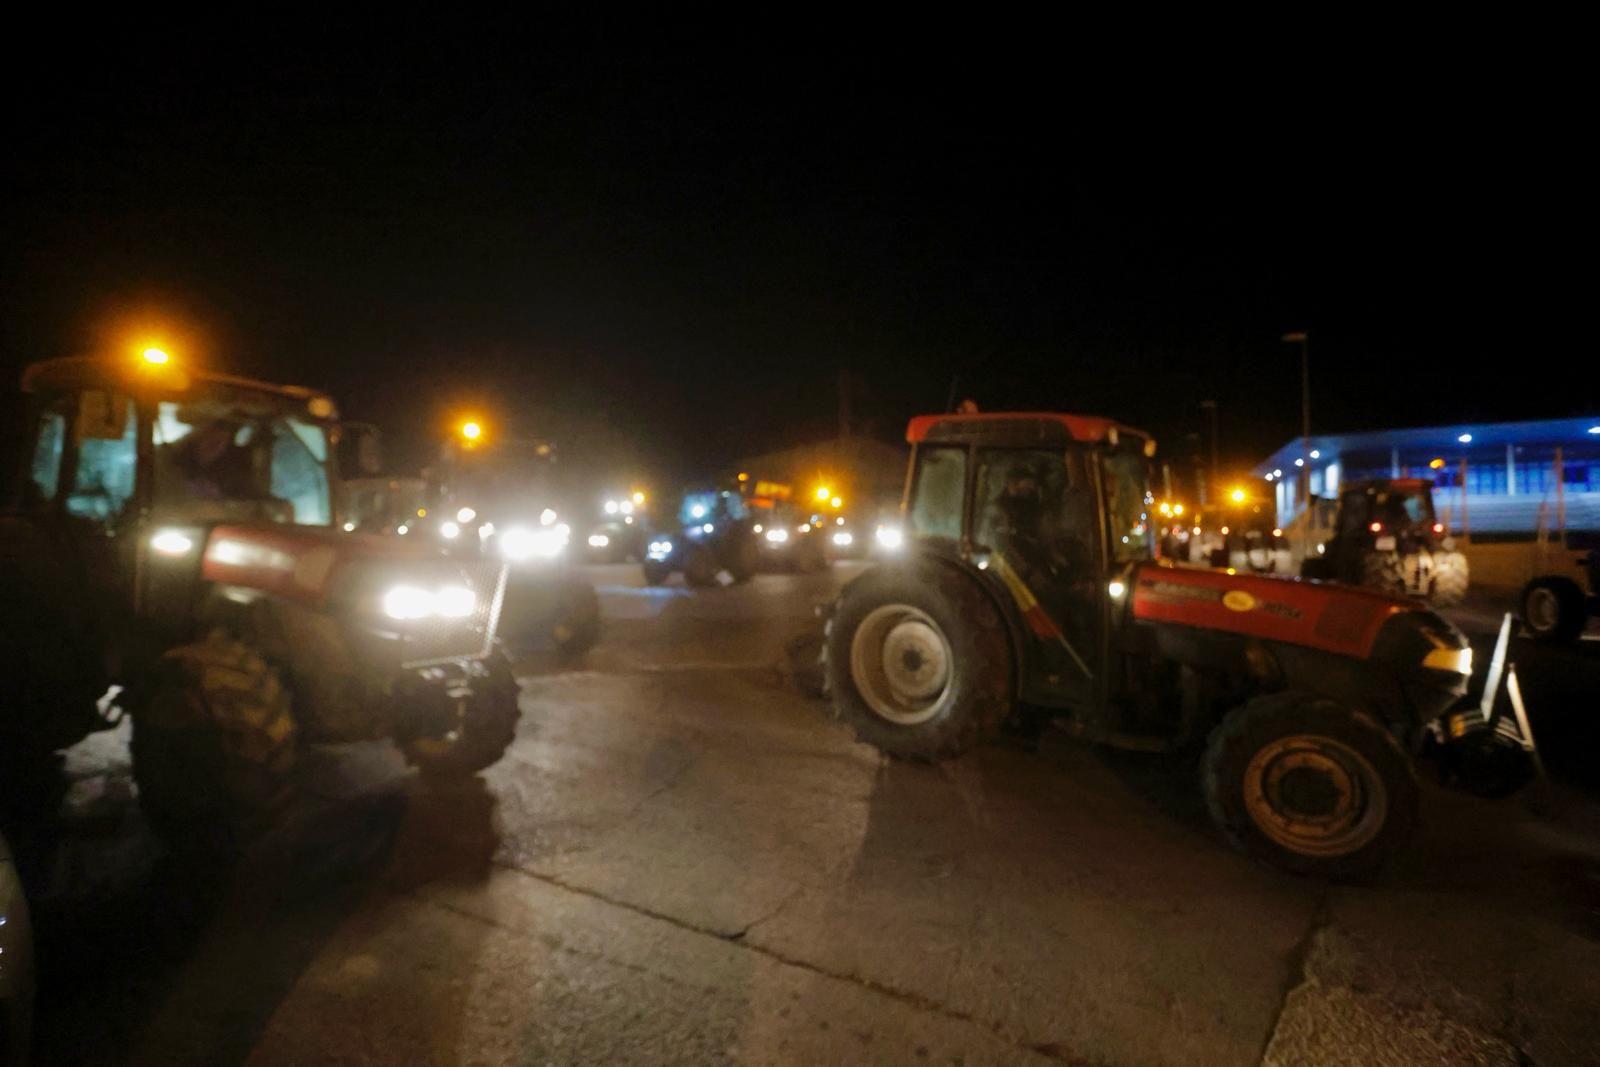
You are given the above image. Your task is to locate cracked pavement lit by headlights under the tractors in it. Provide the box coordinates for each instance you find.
[18,566,1600,1067]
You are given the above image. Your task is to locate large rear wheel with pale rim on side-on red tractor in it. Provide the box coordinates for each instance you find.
[826,566,1013,760]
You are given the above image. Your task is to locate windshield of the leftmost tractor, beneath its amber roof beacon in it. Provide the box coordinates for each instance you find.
[152,397,333,526]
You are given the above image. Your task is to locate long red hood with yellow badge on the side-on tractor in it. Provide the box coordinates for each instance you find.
[1133,563,1467,669]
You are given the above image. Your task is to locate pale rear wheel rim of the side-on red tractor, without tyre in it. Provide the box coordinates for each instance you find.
[850,603,955,726]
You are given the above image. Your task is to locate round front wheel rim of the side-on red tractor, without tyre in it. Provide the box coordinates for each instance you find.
[1245,734,1389,857]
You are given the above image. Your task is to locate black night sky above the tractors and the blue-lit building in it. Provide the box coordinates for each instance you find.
[0,18,1597,475]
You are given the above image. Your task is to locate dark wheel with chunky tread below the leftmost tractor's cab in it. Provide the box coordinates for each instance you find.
[133,632,298,854]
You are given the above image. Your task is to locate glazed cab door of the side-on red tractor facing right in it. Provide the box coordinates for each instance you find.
[968,448,1107,717]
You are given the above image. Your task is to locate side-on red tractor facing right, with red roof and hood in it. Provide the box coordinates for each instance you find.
[822,413,1520,877]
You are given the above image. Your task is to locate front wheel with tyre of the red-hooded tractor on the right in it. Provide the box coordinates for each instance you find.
[1202,693,1418,878]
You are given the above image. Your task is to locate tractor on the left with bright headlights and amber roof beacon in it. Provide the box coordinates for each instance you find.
[0,354,518,849]
